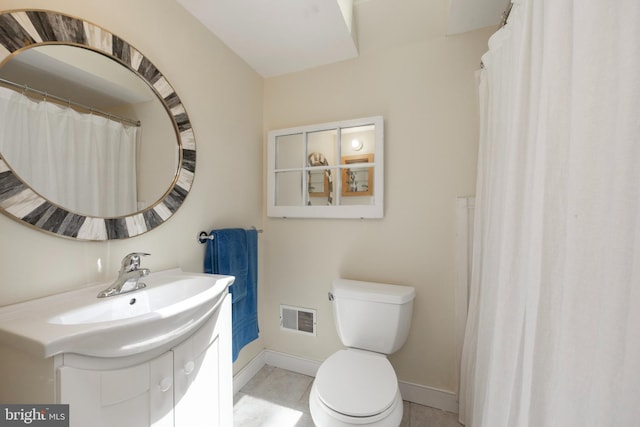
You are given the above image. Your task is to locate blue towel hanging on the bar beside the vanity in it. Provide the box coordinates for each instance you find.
[204,228,258,362]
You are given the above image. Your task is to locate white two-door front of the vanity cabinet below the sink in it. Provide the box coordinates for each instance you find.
[56,295,233,427]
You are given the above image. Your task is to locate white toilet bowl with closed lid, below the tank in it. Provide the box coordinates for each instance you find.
[309,349,403,427]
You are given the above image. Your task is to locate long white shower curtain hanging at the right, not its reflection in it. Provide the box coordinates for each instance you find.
[459,0,640,427]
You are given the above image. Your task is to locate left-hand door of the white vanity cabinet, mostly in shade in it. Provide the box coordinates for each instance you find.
[58,352,173,427]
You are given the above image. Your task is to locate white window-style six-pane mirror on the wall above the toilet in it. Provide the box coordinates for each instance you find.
[269,117,382,217]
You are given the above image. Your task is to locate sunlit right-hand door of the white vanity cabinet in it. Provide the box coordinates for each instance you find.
[173,295,233,427]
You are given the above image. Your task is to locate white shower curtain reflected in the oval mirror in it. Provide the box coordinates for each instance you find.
[0,87,138,221]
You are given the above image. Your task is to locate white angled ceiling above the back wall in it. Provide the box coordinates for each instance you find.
[177,0,509,78]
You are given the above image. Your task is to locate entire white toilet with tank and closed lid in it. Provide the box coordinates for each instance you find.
[309,279,415,427]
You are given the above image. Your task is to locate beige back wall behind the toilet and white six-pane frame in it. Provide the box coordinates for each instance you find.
[261,30,491,390]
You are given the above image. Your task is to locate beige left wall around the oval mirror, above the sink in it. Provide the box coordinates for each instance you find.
[0,0,263,362]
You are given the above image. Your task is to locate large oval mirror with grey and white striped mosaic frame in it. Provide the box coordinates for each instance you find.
[0,10,195,240]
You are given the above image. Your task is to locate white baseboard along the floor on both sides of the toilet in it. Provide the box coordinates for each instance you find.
[233,350,458,413]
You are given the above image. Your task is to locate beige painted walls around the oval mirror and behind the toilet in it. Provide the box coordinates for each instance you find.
[0,0,491,398]
